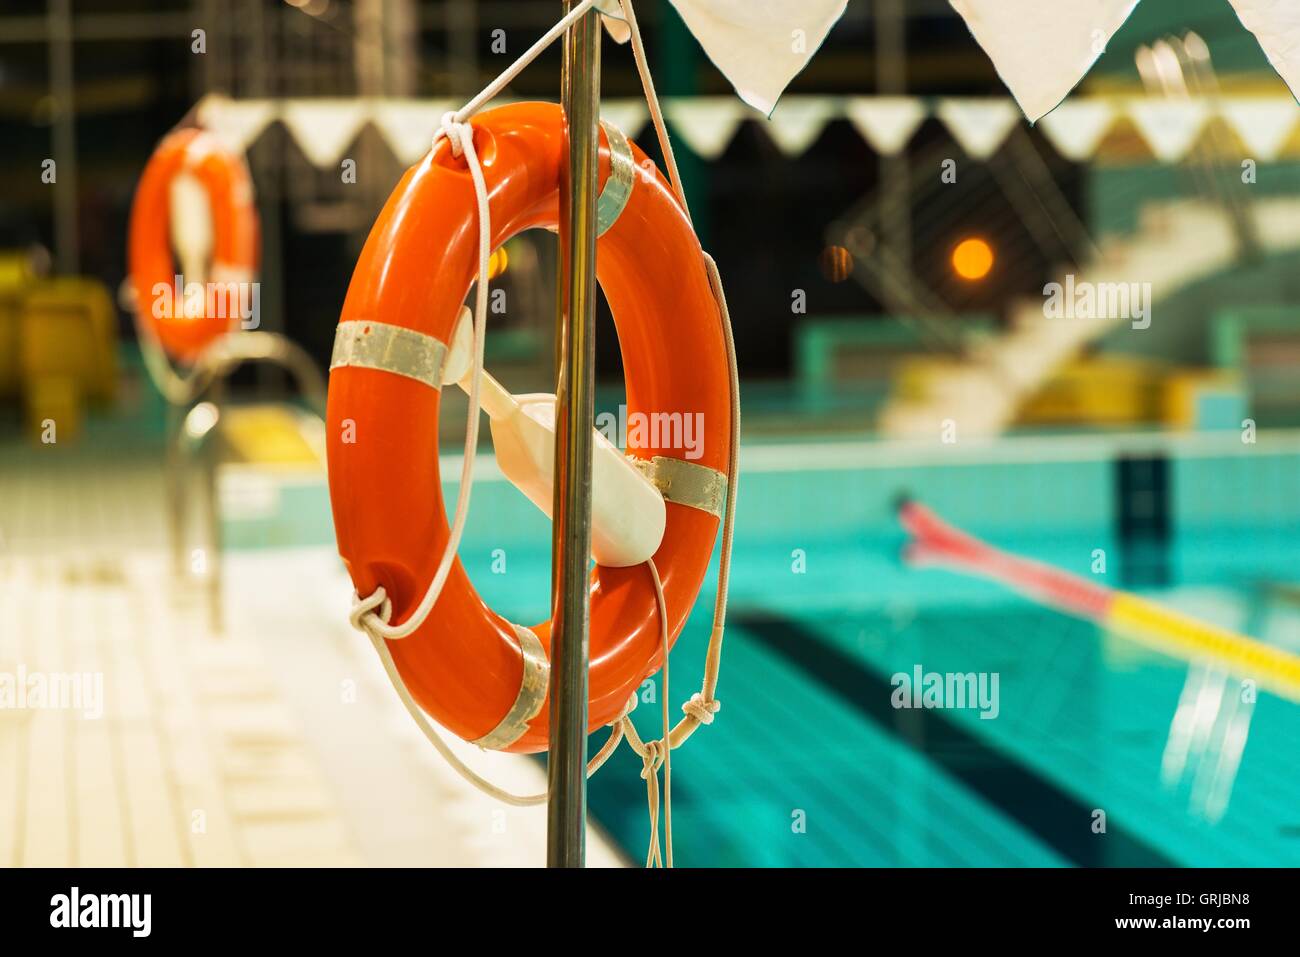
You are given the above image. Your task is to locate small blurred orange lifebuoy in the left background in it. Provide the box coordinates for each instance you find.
[127,129,259,360]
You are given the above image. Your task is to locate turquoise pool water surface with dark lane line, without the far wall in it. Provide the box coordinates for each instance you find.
[484,553,1300,866]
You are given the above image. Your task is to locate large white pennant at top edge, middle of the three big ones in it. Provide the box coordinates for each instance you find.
[949,0,1138,122]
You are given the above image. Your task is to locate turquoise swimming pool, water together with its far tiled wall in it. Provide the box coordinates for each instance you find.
[233,436,1300,866]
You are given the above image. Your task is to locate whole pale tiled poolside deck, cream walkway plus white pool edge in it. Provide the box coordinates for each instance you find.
[0,447,621,866]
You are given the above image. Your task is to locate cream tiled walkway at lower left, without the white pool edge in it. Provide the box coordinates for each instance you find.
[0,554,361,866]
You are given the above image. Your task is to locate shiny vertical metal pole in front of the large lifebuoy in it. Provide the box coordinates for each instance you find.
[546,0,601,867]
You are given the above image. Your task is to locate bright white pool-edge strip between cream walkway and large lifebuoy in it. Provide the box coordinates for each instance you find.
[226,549,621,866]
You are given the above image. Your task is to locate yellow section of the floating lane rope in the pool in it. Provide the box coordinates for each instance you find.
[1106,592,1300,703]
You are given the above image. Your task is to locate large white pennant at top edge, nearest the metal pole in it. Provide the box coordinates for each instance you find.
[672,0,848,114]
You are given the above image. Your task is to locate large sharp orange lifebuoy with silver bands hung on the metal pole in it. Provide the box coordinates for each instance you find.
[326,103,731,752]
